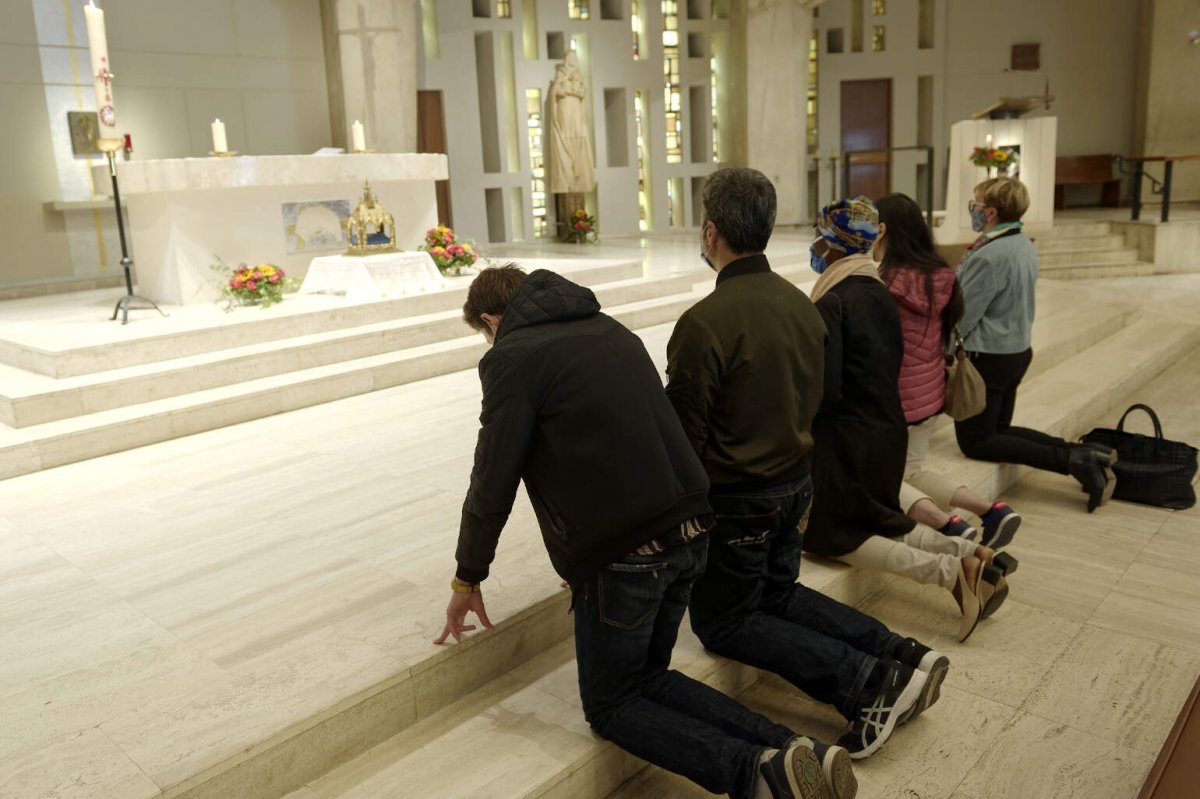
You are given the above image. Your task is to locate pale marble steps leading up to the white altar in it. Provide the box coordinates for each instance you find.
[0,260,697,479]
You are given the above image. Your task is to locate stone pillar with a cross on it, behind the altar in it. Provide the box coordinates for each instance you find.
[320,0,421,152]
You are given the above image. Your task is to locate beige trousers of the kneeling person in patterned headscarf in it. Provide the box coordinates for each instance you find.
[841,524,977,590]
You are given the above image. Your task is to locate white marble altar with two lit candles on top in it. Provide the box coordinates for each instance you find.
[116,154,448,305]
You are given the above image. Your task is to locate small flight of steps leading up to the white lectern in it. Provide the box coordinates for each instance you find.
[1034,222,1159,280]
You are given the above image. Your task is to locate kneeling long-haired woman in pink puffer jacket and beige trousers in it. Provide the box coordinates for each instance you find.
[875,194,1021,551]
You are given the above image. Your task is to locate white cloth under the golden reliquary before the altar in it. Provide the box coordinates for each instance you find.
[300,252,445,302]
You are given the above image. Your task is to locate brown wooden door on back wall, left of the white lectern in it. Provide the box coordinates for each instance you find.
[841,78,892,199]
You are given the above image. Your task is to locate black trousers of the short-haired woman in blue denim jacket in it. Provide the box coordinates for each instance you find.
[954,349,1070,474]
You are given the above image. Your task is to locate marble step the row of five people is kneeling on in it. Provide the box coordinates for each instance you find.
[283,314,1200,799]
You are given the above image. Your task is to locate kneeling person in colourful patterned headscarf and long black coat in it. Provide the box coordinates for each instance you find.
[804,197,1008,641]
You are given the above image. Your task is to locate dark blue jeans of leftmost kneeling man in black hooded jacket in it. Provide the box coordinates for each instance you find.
[574,535,796,798]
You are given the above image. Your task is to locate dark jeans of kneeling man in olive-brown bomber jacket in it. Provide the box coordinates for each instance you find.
[690,477,902,719]
